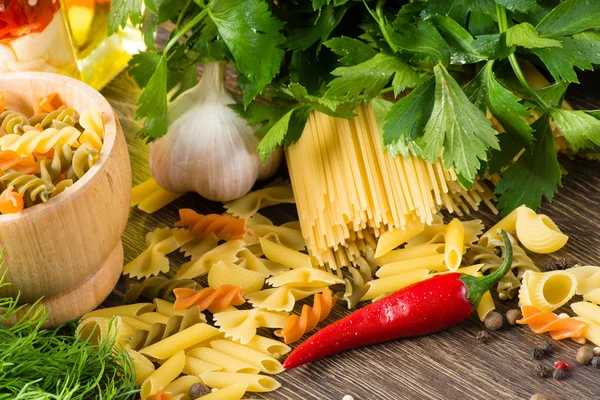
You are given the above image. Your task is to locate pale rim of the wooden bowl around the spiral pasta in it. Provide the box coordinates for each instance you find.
[0,72,118,223]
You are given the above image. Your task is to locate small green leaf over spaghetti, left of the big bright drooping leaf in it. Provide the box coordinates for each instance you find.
[382,77,439,156]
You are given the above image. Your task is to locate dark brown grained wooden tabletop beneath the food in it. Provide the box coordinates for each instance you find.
[102,69,600,400]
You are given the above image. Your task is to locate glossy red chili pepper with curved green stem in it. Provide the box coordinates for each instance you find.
[283,231,512,369]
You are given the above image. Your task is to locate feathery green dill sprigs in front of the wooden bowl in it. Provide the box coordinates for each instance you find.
[0,253,138,400]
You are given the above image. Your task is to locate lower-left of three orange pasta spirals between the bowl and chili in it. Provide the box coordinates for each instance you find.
[173,285,246,311]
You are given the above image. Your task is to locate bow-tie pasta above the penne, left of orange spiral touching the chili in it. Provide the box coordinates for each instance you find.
[213,308,289,344]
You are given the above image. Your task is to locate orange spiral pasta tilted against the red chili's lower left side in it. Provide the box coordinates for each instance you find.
[275,288,336,344]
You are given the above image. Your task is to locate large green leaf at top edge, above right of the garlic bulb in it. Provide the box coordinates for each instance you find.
[208,0,285,105]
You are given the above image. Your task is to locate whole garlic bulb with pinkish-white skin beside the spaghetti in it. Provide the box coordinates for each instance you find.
[150,63,282,201]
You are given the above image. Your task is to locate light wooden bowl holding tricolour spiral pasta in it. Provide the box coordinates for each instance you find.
[0,72,131,327]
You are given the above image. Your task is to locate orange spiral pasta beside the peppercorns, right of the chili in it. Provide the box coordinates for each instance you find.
[517,306,587,344]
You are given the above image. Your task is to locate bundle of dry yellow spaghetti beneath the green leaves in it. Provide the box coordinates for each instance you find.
[286,104,495,269]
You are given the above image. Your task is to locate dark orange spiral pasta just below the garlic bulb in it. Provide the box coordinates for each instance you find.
[175,208,252,240]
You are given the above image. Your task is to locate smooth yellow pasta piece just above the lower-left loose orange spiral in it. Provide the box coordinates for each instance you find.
[208,261,265,293]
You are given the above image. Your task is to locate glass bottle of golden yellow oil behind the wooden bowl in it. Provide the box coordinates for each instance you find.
[62,0,145,89]
